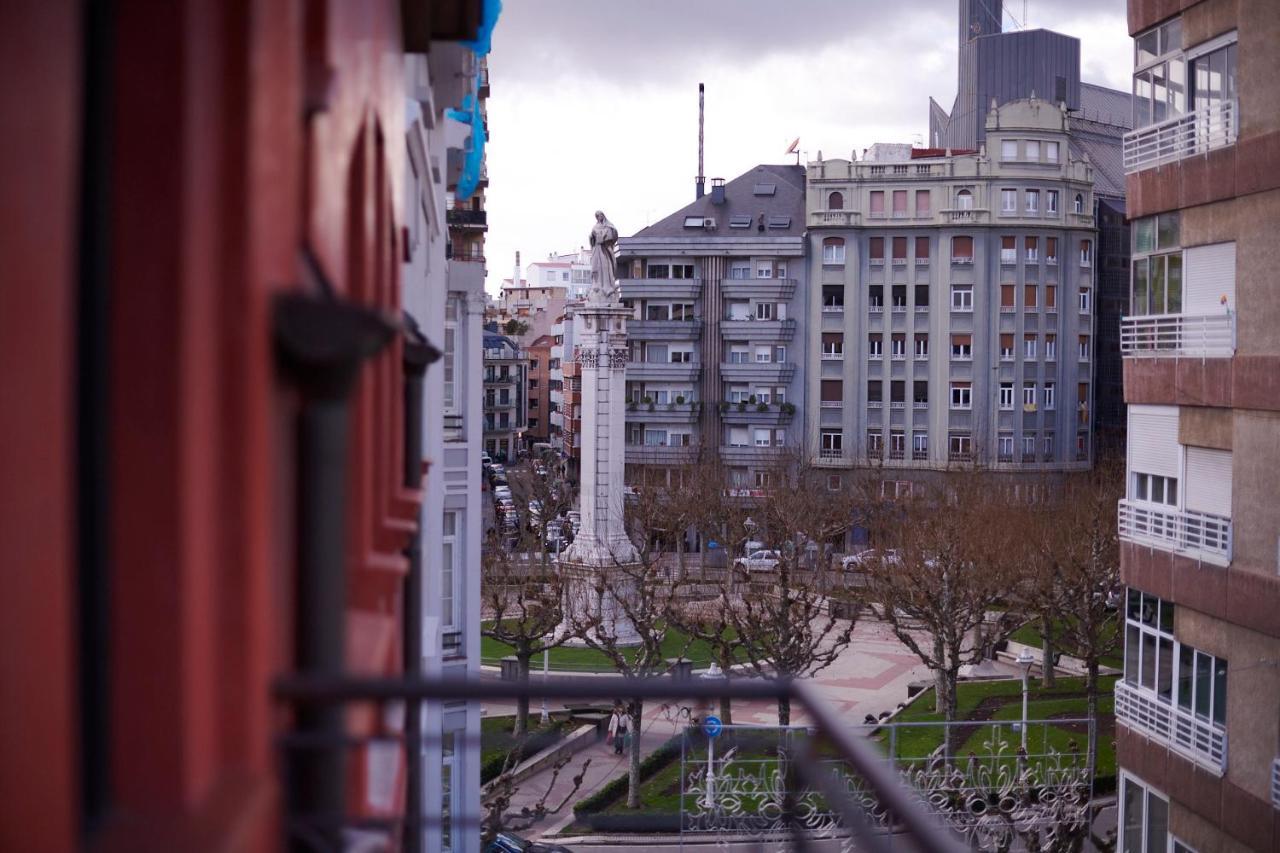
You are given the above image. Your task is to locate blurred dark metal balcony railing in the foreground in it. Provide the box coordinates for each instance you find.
[275,675,962,853]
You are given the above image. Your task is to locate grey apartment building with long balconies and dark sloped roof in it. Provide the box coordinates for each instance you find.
[618,165,806,493]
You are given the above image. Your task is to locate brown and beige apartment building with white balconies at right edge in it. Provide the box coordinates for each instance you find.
[1116,0,1280,853]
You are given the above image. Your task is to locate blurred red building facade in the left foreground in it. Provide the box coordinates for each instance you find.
[0,0,480,850]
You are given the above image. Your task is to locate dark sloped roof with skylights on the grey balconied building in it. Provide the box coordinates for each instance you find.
[632,164,805,238]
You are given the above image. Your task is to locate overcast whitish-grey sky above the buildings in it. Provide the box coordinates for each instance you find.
[485,0,1132,292]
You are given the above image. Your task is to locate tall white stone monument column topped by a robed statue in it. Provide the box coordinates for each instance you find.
[558,211,640,644]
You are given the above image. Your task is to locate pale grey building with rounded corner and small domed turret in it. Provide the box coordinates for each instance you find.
[805,100,1096,479]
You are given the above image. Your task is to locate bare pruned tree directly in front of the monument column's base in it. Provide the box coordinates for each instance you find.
[566,483,690,808]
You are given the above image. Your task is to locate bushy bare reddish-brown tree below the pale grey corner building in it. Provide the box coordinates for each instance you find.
[865,471,1018,721]
